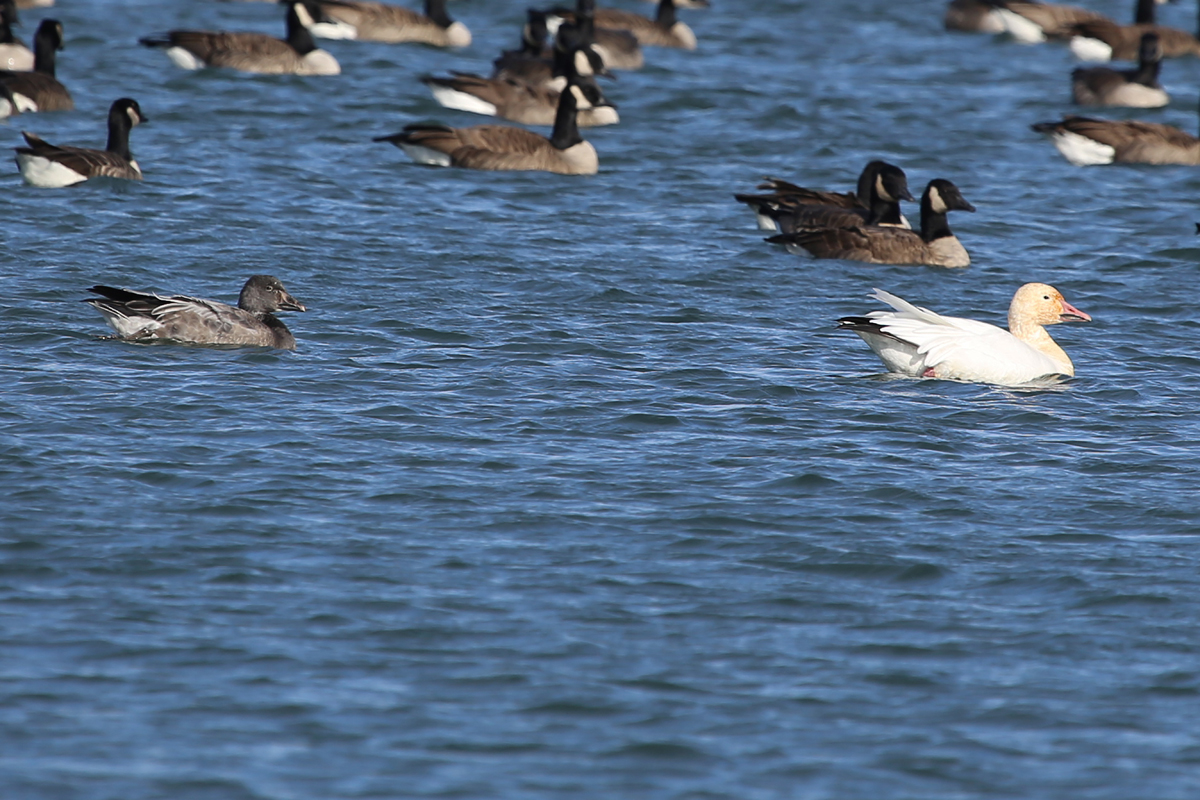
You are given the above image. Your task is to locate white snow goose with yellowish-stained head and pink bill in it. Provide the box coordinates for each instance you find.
[838,283,1092,386]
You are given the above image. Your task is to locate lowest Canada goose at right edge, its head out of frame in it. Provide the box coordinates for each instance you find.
[1032,97,1200,167]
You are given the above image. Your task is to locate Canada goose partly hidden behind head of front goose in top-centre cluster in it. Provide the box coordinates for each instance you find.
[421,25,620,127]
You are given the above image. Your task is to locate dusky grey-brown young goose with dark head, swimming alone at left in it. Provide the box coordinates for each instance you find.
[84,275,307,350]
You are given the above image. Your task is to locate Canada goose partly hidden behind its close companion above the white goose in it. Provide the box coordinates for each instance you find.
[733,161,914,234]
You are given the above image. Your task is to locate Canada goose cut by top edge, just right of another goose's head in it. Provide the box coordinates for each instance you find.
[311,0,470,47]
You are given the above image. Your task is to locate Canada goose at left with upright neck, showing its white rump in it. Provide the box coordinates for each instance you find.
[16,97,146,188]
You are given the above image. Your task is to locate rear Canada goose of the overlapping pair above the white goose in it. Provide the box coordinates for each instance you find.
[733,161,913,233]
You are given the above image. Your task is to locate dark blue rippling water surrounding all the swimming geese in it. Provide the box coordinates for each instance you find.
[0,0,1200,800]
